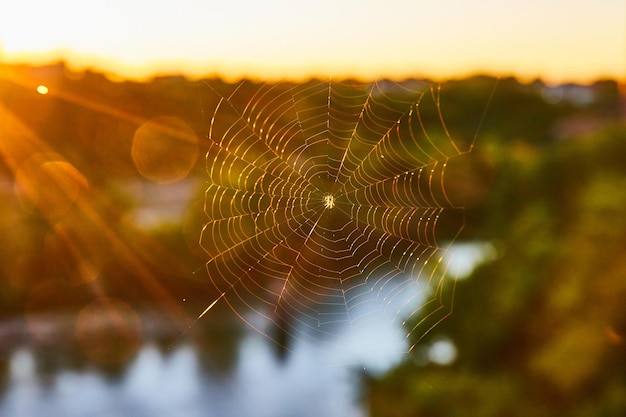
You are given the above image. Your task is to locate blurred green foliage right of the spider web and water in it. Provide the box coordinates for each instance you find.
[367,113,626,417]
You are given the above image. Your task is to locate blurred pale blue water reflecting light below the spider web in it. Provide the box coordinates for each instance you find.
[0,244,492,417]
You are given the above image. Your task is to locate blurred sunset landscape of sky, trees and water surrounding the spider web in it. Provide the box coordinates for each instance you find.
[0,0,626,416]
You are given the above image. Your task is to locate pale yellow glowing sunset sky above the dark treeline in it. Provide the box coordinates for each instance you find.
[0,0,626,81]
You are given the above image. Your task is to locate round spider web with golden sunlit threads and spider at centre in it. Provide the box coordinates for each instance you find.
[200,80,472,348]
